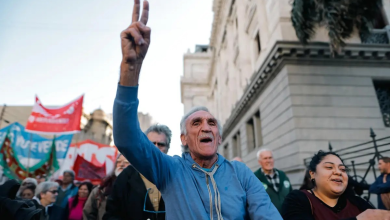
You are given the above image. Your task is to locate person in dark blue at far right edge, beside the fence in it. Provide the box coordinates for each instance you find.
[370,157,390,210]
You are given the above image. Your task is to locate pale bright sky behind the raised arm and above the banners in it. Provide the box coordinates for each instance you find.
[0,0,213,155]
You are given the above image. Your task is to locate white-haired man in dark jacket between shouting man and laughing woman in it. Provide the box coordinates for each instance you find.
[255,149,292,211]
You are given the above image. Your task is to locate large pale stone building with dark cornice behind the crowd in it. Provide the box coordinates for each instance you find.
[181,0,390,188]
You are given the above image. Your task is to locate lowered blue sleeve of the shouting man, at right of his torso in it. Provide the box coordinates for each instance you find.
[243,164,282,220]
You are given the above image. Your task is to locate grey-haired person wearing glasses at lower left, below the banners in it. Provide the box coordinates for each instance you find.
[34,181,68,220]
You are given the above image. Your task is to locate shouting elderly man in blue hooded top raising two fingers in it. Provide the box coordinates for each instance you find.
[113,0,282,220]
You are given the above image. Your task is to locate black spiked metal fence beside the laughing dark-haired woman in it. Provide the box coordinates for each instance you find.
[303,128,390,200]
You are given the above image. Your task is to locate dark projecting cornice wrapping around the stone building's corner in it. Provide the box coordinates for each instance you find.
[223,41,390,139]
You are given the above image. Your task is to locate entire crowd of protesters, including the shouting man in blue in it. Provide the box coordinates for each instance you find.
[0,0,390,220]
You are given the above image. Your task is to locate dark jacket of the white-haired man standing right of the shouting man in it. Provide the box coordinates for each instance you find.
[255,169,292,212]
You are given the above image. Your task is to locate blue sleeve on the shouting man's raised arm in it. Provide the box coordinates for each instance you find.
[113,84,174,190]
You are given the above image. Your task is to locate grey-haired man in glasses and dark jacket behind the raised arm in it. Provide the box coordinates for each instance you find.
[103,124,172,220]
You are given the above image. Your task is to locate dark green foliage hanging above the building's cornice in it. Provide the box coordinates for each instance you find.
[291,0,382,52]
